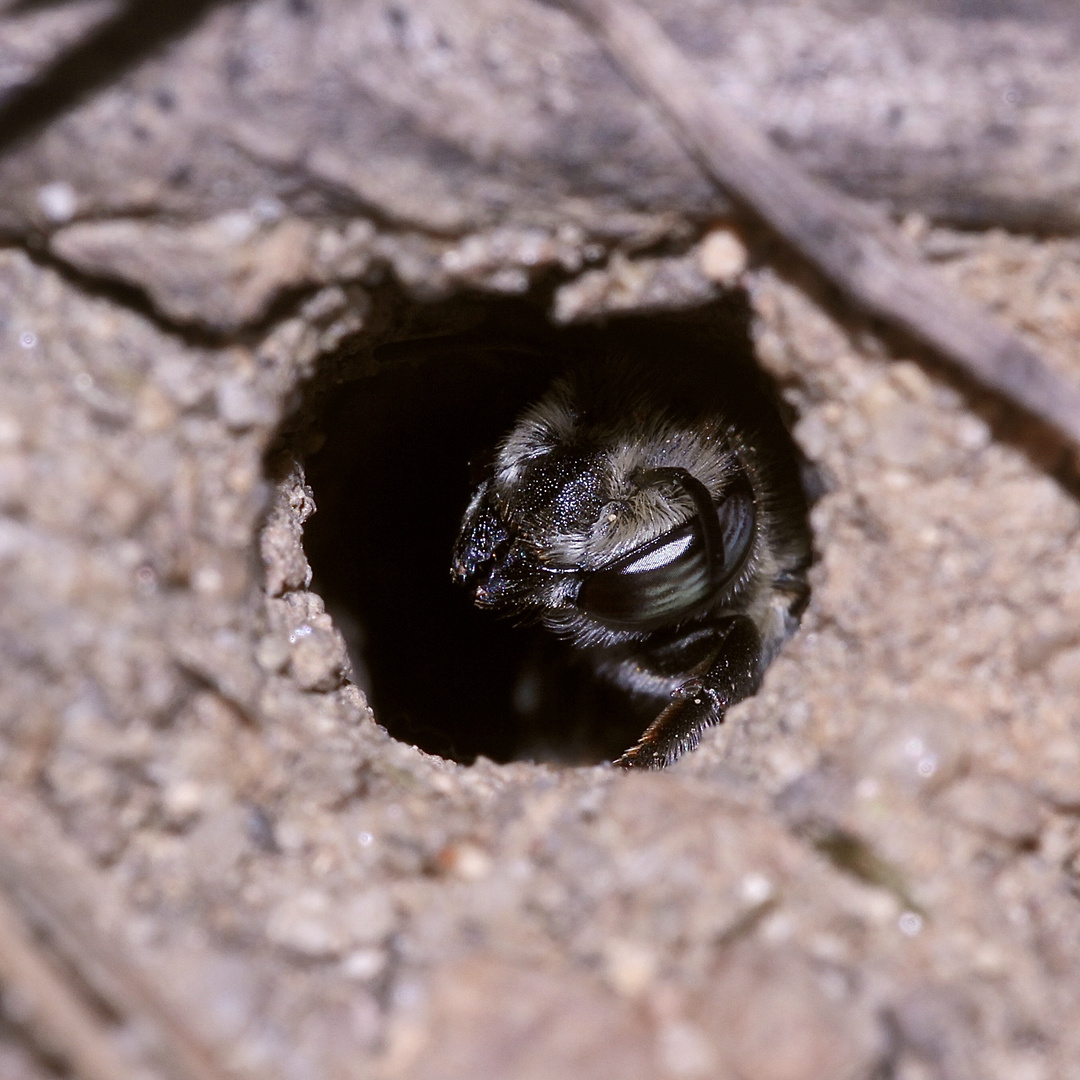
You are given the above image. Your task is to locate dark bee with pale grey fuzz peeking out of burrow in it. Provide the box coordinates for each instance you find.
[451,321,811,768]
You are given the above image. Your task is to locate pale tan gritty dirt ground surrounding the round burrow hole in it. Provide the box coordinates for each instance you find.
[0,5,1080,1080]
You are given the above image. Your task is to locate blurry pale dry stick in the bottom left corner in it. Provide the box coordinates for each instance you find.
[0,791,235,1080]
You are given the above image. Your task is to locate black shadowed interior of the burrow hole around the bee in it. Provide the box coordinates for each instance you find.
[305,297,781,764]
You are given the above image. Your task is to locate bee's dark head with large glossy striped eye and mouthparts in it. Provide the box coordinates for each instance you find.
[454,436,755,634]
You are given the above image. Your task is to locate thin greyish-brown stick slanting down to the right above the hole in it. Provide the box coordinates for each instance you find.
[561,0,1080,447]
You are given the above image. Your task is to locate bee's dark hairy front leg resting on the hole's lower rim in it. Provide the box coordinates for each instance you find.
[615,617,761,769]
